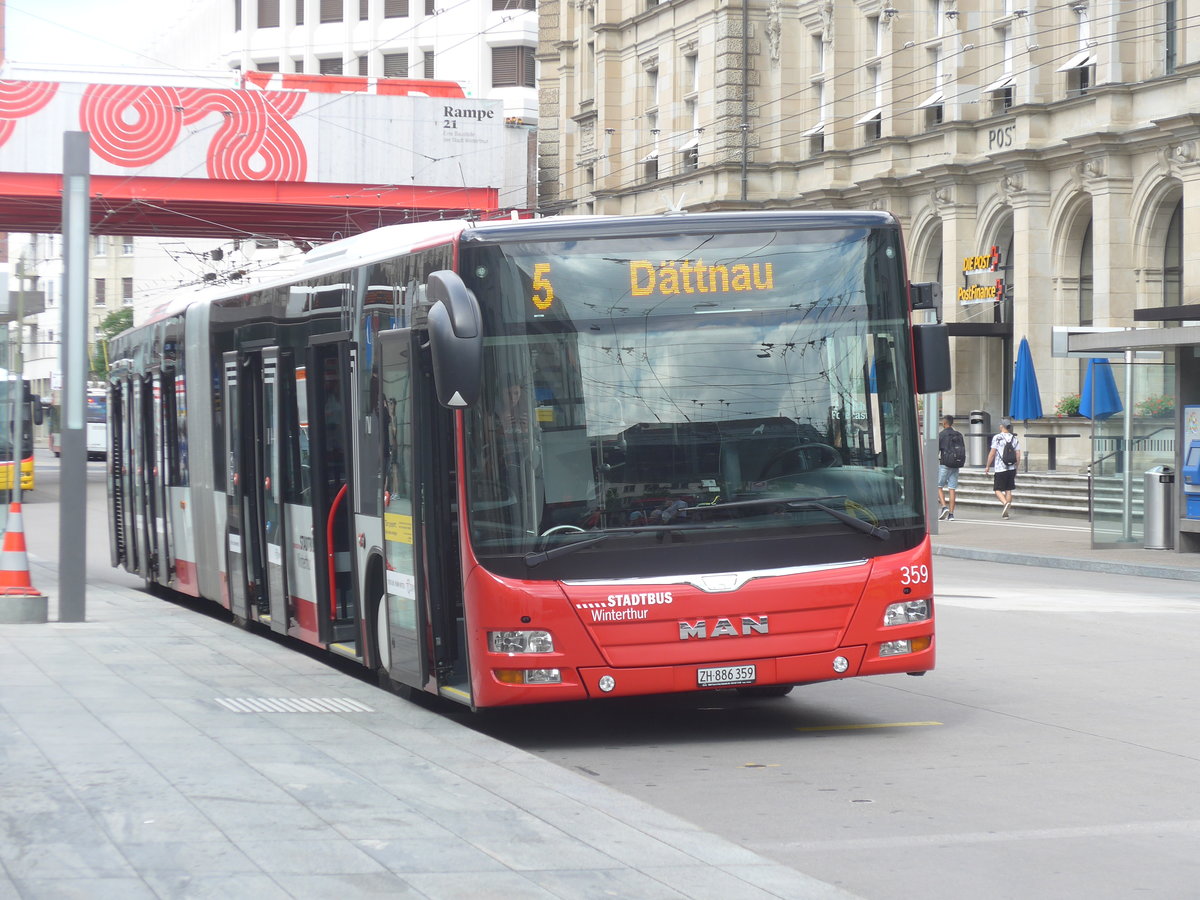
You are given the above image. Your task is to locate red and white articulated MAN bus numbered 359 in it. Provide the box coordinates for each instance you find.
[109,211,949,708]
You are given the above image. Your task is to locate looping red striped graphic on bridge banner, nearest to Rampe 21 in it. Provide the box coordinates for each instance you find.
[180,88,308,181]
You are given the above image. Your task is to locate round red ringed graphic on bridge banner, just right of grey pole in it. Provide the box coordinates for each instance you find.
[79,84,184,167]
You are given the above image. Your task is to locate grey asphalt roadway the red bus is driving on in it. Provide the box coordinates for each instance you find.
[24,457,1200,900]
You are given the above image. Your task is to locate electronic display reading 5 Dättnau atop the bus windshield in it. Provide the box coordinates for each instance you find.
[462,227,907,329]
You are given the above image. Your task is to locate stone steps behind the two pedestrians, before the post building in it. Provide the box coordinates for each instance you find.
[936,467,1144,522]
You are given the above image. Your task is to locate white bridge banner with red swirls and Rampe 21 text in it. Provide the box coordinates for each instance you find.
[0,77,504,186]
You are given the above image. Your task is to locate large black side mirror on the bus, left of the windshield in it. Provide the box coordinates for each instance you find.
[426,270,484,409]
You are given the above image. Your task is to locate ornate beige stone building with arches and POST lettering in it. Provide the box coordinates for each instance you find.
[539,0,1200,463]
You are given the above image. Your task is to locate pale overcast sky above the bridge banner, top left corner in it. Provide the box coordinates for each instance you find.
[2,0,182,68]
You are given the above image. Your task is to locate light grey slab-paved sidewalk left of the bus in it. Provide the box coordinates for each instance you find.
[0,559,850,900]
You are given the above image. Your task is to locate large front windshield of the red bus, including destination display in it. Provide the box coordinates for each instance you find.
[463,228,923,577]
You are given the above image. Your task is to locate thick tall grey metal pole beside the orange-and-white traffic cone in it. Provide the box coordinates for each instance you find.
[59,131,91,622]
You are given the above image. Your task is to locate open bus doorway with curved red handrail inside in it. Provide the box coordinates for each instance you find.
[305,335,364,658]
